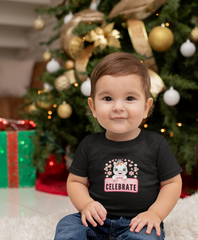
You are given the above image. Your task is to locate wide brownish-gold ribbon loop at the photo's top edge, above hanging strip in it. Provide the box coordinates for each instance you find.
[109,0,169,20]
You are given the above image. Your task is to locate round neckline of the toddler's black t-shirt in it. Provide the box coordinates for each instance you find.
[99,129,146,148]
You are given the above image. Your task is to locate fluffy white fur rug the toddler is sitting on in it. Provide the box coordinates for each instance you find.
[0,192,198,240]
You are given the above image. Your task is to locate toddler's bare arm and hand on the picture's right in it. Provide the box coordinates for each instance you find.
[129,174,182,236]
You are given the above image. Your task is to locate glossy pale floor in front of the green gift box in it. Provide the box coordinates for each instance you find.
[0,187,76,217]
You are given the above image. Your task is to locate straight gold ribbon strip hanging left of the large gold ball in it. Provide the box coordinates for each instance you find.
[127,20,158,72]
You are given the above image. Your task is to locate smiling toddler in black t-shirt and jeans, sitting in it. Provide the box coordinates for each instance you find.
[55,52,182,240]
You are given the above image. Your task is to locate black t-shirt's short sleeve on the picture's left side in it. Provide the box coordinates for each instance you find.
[68,138,88,177]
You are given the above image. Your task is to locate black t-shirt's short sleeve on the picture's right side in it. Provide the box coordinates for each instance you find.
[157,138,182,182]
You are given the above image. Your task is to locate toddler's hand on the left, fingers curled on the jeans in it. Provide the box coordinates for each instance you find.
[81,201,107,227]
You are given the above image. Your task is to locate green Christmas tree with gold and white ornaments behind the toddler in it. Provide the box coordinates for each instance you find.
[21,0,198,172]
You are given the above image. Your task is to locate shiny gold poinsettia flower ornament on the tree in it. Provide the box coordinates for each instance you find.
[85,22,121,50]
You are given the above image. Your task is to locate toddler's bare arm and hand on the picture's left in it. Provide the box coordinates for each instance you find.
[67,173,107,227]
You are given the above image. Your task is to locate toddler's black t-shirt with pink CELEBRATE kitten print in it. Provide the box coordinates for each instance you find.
[69,129,182,219]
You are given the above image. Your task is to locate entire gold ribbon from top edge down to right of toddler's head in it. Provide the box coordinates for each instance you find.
[109,0,169,97]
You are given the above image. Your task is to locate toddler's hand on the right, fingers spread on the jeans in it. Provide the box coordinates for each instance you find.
[129,210,161,236]
